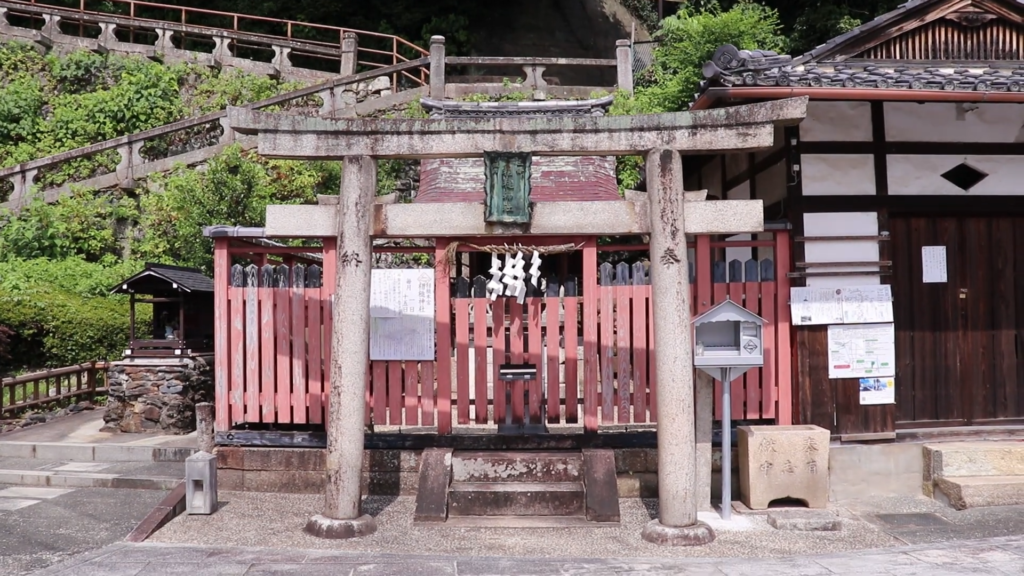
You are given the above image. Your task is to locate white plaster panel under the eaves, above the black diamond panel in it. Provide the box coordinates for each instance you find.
[884,102,1024,142]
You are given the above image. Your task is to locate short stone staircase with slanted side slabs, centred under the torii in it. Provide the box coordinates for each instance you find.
[416,450,618,528]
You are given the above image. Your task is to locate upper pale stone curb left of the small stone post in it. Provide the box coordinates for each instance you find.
[0,442,196,462]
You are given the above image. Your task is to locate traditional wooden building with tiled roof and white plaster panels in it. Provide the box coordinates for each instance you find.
[687,0,1024,440]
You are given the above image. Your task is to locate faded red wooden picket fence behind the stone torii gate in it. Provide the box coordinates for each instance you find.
[215,231,792,434]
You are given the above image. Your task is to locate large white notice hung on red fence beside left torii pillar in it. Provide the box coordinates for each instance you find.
[370,269,434,360]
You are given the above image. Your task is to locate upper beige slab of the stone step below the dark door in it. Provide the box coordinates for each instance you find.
[925,440,1024,482]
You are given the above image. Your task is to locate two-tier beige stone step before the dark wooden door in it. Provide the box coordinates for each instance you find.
[924,440,1024,510]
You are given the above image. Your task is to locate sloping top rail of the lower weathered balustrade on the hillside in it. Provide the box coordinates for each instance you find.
[0,57,430,177]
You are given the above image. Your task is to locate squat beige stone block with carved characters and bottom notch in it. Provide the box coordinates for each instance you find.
[737,425,828,509]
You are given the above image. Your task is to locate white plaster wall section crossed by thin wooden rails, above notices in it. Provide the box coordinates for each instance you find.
[804,212,881,288]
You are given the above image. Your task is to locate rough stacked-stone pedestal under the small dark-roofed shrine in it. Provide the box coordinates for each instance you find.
[103,356,213,434]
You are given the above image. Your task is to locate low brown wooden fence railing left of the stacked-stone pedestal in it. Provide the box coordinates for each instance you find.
[0,362,106,414]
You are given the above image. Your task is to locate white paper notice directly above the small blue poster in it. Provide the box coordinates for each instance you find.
[828,324,896,378]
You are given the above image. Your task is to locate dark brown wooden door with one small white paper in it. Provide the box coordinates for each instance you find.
[891,216,1024,427]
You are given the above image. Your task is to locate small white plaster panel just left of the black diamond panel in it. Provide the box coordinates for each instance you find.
[801,154,874,196]
